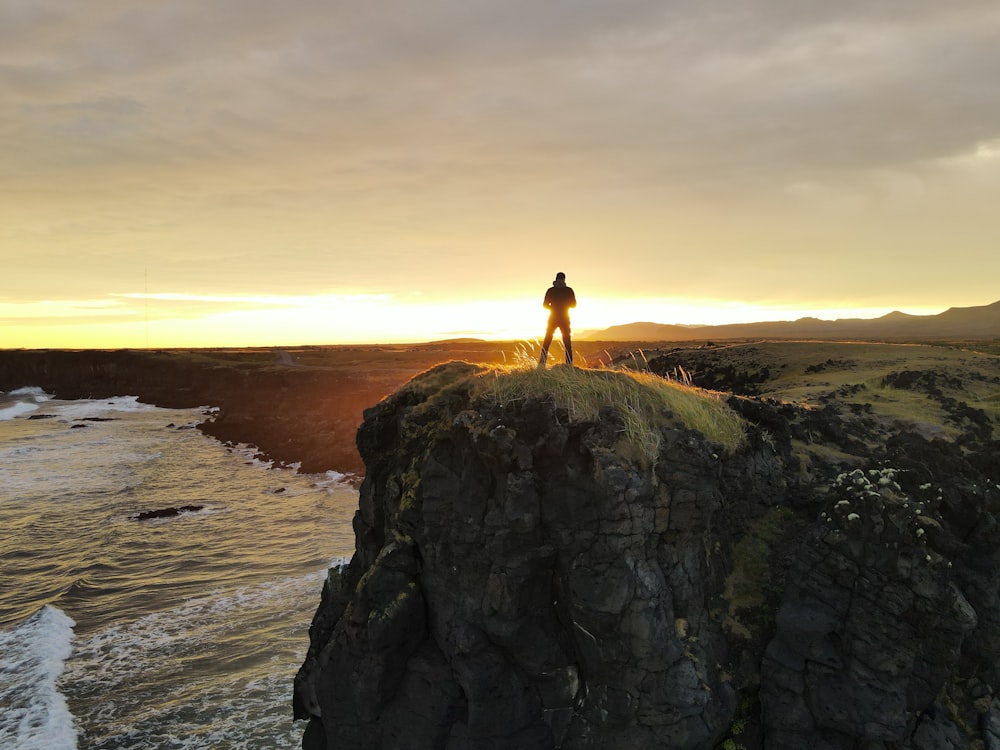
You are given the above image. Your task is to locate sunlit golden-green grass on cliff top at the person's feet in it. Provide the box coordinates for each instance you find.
[479,359,746,461]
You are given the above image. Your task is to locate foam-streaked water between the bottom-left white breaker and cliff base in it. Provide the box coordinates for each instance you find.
[58,570,325,750]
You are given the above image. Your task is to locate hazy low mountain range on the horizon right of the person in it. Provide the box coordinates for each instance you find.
[578,301,1000,341]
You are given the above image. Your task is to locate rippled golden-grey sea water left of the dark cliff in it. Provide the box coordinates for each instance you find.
[0,389,357,750]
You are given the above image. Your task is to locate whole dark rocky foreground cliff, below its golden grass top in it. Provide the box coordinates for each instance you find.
[295,363,1000,750]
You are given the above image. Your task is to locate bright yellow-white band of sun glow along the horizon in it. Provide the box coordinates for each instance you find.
[0,292,956,349]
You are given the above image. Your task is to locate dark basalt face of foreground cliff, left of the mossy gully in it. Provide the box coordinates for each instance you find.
[296,365,782,749]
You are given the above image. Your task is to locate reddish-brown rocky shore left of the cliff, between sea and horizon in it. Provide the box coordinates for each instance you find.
[0,349,466,476]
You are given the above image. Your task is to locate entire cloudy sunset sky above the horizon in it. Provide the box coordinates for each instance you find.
[0,0,1000,348]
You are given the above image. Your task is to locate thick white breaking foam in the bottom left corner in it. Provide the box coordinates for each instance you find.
[0,605,76,750]
